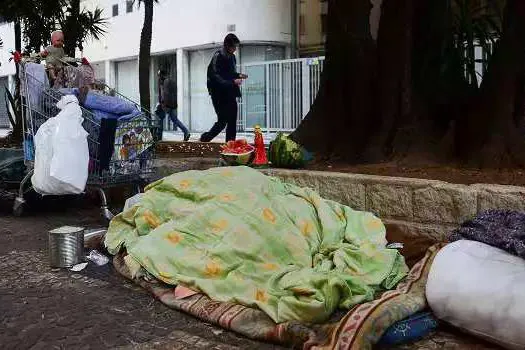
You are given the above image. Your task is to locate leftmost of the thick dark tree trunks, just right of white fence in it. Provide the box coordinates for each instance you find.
[291,0,376,161]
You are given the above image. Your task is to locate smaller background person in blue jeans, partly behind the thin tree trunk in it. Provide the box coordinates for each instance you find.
[155,70,190,141]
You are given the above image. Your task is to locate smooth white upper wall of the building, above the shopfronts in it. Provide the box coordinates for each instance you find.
[83,0,291,62]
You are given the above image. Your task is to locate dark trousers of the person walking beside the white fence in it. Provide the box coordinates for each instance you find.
[201,94,237,142]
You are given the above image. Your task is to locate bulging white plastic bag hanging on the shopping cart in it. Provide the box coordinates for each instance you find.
[31,95,89,195]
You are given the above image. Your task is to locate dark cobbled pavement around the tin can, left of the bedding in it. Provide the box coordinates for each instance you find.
[0,204,279,350]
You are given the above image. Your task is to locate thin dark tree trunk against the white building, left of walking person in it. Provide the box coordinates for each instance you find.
[139,0,153,110]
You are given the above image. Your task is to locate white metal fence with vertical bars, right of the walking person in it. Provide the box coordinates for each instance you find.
[238,57,324,132]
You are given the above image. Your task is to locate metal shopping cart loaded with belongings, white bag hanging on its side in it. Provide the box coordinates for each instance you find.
[13,60,158,220]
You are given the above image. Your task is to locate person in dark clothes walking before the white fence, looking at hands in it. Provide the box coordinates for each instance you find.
[200,34,248,142]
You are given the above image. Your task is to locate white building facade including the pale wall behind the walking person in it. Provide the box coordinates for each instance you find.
[0,0,293,132]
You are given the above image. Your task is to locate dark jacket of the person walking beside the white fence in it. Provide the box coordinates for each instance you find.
[207,48,241,98]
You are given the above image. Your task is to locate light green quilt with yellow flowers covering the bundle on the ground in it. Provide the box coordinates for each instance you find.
[105,167,408,323]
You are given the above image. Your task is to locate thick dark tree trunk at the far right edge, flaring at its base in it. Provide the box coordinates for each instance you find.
[458,0,525,167]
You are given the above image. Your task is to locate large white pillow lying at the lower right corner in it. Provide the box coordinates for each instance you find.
[426,240,525,349]
